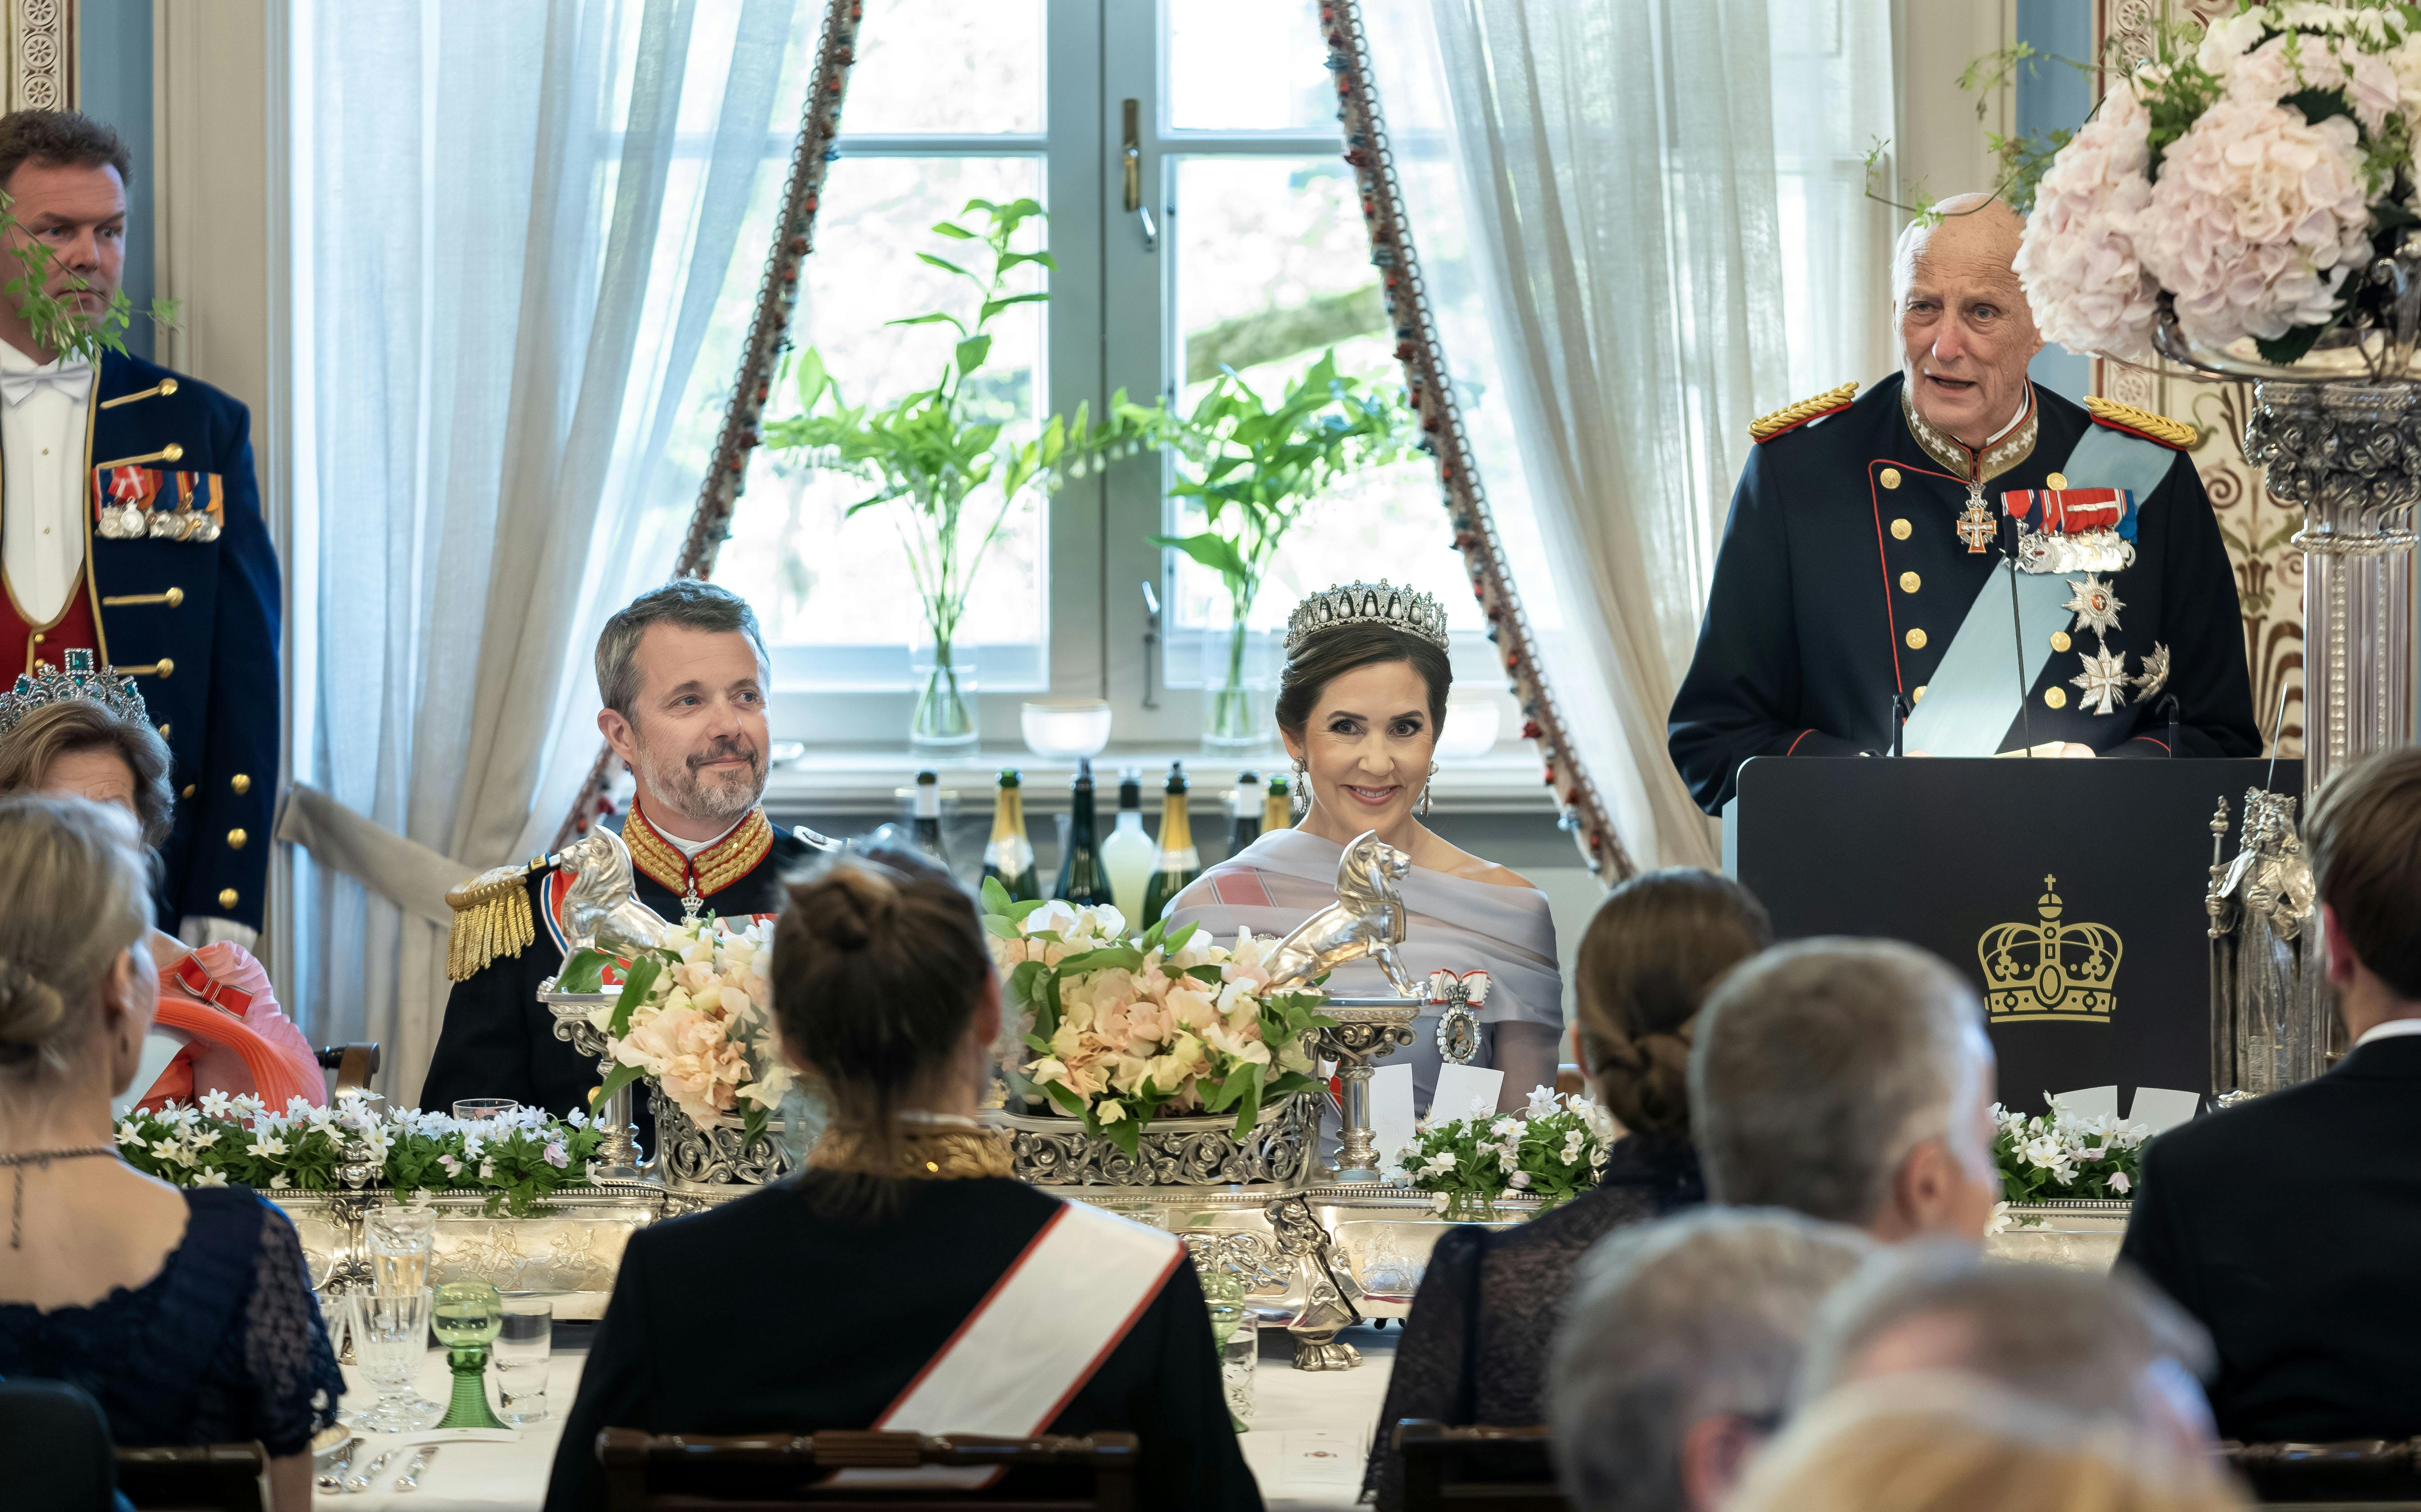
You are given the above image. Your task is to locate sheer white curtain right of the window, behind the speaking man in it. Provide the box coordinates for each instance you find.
[1370,0,1893,866]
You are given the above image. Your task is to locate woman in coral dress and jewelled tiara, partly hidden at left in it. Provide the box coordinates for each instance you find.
[0,682,327,1110]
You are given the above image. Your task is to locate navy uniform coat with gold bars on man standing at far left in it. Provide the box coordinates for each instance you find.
[0,353,278,931]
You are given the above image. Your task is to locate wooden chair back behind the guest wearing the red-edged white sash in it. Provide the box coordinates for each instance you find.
[598,1427,1143,1512]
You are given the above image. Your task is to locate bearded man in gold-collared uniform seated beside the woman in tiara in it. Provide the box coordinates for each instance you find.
[421,578,837,1115]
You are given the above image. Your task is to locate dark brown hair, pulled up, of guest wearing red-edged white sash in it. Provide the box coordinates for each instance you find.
[772,852,993,1151]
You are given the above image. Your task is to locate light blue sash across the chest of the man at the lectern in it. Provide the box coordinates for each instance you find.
[1901,426,2177,757]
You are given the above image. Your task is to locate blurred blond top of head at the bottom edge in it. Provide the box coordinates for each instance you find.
[1726,1374,2247,1512]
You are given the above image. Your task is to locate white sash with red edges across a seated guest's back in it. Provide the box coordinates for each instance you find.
[828,1202,1186,1488]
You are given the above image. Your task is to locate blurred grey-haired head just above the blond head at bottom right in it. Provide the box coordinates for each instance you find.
[1797,1243,2213,1454]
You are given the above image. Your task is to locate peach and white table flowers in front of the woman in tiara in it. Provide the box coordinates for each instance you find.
[983,880,1331,1154]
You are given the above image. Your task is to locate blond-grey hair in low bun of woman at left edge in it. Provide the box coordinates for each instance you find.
[0,794,153,1079]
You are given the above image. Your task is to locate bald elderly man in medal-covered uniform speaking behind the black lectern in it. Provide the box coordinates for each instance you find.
[1668,194,2261,813]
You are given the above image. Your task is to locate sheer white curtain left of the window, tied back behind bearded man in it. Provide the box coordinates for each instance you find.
[281,0,816,1098]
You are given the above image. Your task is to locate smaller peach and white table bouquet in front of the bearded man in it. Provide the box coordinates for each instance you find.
[559,915,792,1144]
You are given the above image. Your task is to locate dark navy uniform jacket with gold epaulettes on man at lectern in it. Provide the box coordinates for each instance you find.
[1665,375,2261,813]
